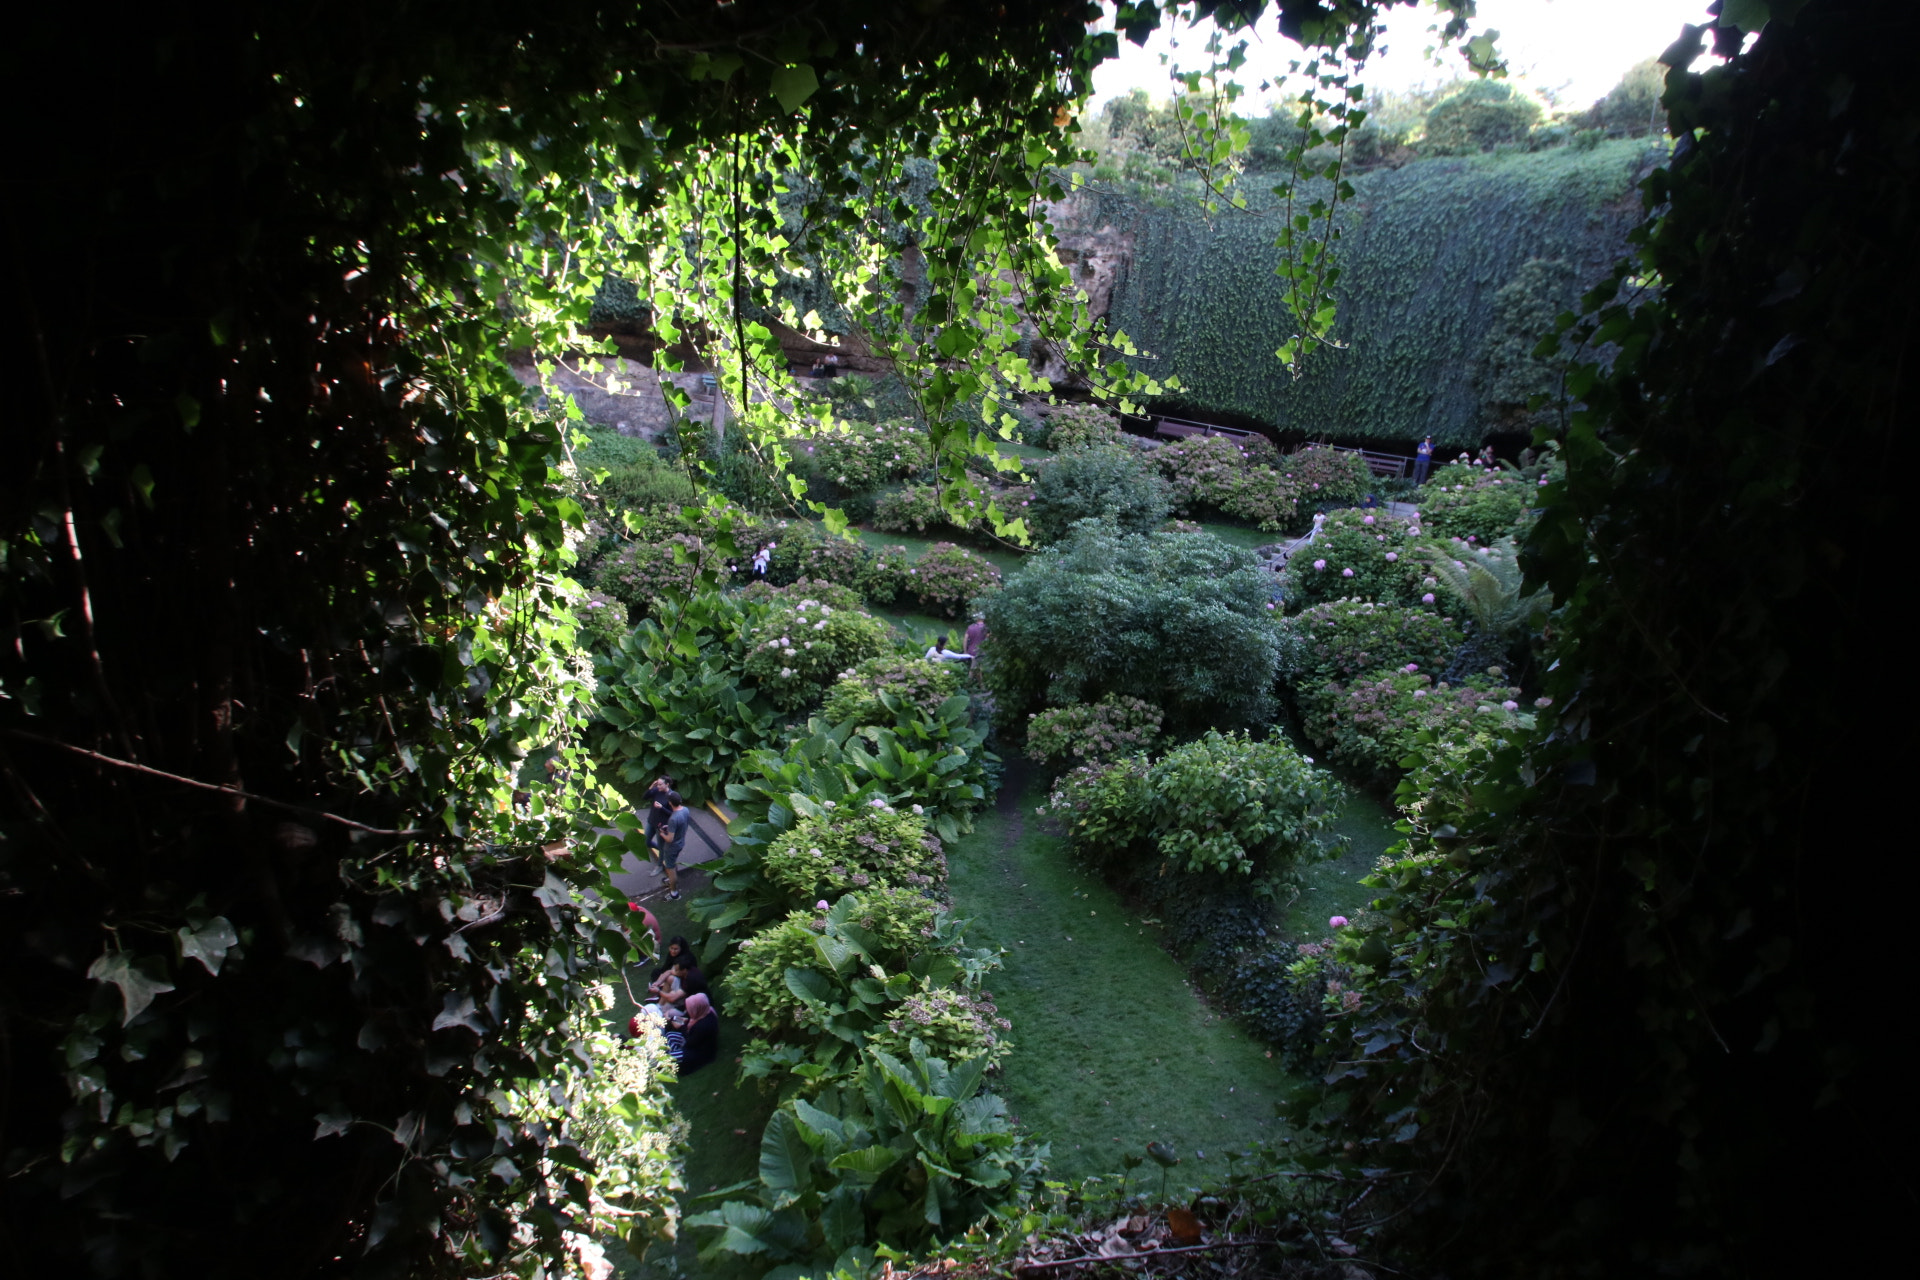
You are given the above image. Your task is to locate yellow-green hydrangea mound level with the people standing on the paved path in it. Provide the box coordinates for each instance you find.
[760,808,947,902]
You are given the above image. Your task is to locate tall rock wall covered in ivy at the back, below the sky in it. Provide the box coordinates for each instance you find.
[1054,138,1647,449]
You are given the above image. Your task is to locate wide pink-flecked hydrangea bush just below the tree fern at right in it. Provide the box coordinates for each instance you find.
[1300,668,1534,773]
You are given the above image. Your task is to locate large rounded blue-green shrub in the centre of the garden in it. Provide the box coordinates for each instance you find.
[981,522,1277,729]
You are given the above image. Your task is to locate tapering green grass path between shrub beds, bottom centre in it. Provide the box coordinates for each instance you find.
[948,770,1294,1178]
